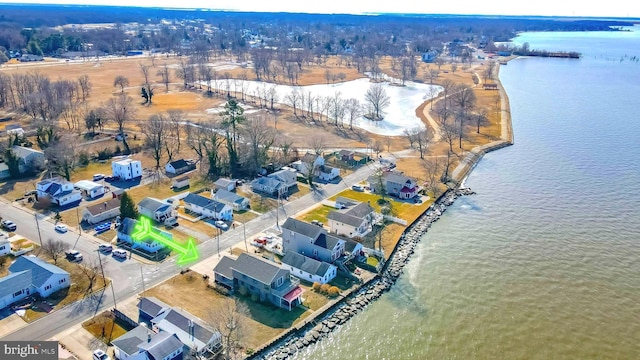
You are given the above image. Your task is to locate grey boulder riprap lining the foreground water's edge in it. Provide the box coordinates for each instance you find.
[251,188,475,360]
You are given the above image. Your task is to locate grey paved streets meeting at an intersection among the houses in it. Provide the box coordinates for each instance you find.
[2,160,377,340]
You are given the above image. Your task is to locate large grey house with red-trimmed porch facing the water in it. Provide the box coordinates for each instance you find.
[213,253,302,311]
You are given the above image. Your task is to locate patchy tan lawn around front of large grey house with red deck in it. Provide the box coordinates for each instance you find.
[142,272,312,349]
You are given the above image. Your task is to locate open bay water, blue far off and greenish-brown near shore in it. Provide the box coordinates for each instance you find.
[294,27,640,360]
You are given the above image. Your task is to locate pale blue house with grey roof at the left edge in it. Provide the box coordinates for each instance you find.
[0,256,71,309]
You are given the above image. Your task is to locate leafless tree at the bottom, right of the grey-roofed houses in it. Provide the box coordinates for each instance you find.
[207,298,250,360]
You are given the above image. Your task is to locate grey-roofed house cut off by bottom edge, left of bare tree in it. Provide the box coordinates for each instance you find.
[111,325,185,360]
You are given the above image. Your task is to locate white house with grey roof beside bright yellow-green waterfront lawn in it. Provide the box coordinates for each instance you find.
[327,202,376,238]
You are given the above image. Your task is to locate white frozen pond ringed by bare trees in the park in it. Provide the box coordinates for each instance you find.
[204,78,442,136]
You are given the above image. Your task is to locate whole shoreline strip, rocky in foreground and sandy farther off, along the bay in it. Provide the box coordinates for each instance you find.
[246,65,514,360]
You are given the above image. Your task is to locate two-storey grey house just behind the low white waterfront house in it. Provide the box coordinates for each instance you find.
[282,217,345,264]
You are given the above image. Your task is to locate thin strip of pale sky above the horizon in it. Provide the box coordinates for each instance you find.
[0,0,640,18]
